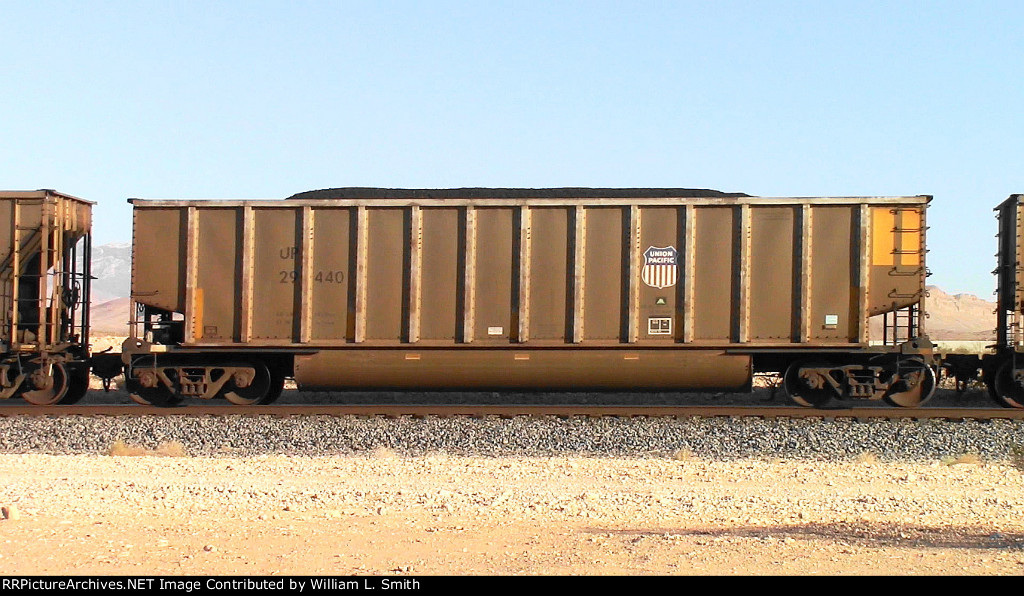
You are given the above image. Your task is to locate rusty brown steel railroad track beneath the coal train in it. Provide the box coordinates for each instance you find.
[0,402,1024,420]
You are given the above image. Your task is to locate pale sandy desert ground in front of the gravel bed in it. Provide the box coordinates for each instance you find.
[0,445,1024,576]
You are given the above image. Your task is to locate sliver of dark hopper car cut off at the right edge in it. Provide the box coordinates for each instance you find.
[982,195,1024,408]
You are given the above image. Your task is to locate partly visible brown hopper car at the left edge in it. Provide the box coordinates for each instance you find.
[0,190,92,405]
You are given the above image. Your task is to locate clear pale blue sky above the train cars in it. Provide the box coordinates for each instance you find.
[0,0,1024,298]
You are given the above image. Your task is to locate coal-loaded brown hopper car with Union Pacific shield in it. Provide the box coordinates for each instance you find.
[124,188,930,405]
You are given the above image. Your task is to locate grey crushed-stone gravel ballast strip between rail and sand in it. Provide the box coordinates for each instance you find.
[0,416,1024,461]
